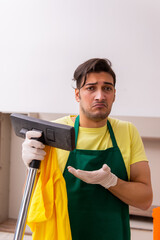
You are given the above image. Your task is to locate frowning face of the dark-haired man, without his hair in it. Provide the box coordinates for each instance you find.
[75,72,116,122]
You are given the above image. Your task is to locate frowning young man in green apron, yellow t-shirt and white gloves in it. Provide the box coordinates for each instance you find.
[23,58,152,240]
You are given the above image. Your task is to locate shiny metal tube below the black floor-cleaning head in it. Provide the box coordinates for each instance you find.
[13,167,38,240]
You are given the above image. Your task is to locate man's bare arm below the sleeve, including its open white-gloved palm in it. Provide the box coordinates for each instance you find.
[68,162,152,210]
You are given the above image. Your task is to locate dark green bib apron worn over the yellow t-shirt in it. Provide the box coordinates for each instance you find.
[63,116,130,240]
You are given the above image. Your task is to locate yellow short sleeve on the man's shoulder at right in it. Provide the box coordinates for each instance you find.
[129,123,148,164]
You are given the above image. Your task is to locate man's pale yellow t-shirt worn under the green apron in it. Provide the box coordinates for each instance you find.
[55,116,148,179]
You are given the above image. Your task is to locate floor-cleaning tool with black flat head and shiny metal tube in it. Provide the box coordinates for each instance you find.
[10,113,75,240]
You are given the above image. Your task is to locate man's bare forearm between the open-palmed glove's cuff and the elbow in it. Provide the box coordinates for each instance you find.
[108,178,153,210]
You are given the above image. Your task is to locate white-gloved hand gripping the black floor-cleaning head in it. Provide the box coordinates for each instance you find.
[22,131,46,167]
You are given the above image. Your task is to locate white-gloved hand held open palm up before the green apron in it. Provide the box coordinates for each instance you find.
[68,164,118,189]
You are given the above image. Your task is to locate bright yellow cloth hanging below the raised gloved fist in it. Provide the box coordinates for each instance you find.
[27,146,72,240]
